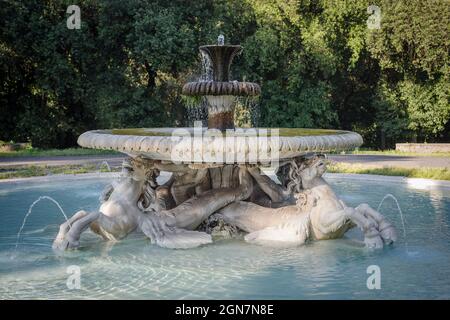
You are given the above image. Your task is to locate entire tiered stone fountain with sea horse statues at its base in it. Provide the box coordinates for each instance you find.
[53,36,396,250]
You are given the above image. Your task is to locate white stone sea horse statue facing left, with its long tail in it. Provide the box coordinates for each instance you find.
[53,159,253,250]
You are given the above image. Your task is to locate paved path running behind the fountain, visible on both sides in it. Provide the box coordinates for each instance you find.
[0,155,450,168]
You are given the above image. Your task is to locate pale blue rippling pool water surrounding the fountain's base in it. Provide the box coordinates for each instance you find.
[0,176,450,299]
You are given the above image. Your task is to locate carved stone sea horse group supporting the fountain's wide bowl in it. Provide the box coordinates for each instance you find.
[53,156,396,250]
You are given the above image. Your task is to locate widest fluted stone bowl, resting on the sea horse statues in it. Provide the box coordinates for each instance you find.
[78,128,363,163]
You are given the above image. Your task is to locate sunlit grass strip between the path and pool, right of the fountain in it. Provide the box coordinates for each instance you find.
[328,163,450,180]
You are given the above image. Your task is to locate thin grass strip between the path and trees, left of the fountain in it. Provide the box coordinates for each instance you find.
[0,148,120,157]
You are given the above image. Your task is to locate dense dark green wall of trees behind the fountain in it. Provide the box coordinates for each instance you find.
[0,0,450,148]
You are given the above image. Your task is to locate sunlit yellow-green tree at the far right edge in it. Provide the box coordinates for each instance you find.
[368,0,450,140]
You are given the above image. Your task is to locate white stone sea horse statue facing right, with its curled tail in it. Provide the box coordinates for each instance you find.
[218,156,397,248]
